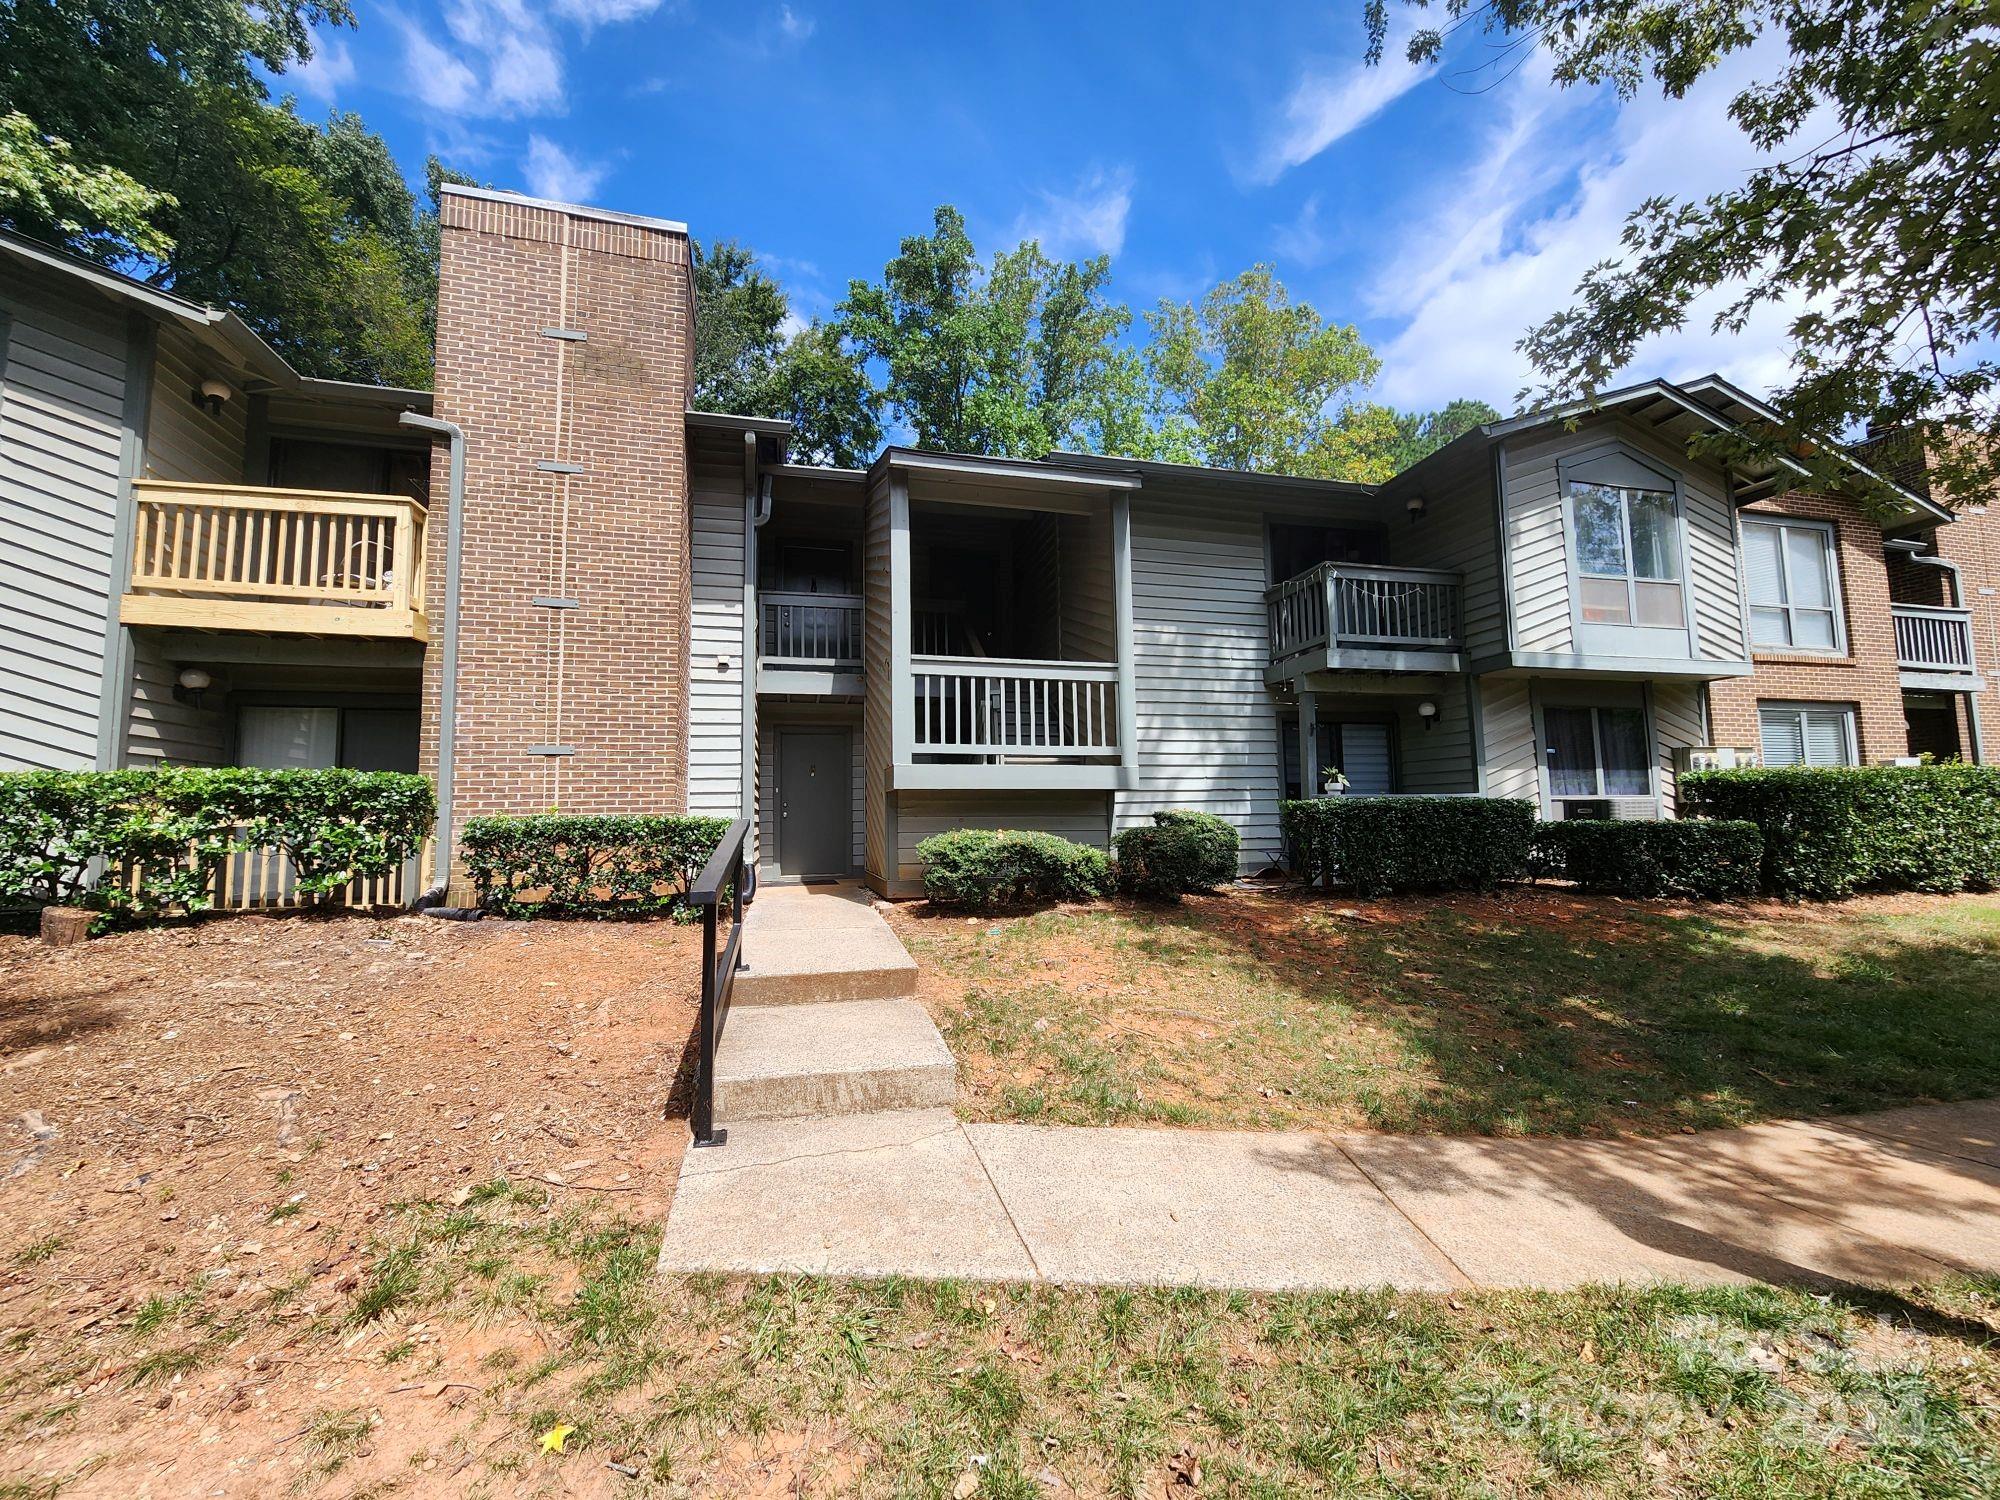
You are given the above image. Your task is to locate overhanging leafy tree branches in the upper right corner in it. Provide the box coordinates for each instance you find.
[1366,0,2000,506]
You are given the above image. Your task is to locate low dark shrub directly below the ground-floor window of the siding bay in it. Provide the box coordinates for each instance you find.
[1534,818,1764,900]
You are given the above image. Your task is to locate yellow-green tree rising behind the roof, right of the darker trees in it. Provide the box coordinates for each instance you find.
[1144,266,1396,480]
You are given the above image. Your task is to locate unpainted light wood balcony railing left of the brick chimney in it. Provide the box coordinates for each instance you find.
[118,480,430,640]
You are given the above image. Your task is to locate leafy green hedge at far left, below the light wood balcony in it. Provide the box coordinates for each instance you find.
[0,766,436,920]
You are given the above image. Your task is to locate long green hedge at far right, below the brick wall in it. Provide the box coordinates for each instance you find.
[1680,766,2000,900]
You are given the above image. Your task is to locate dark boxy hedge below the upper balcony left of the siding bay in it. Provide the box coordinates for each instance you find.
[1278,796,1536,896]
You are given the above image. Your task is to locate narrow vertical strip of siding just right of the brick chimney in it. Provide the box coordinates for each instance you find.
[688,462,746,818]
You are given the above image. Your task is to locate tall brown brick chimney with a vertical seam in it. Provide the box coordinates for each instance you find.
[422,190,692,836]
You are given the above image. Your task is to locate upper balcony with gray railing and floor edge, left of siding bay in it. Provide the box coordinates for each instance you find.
[1264,562,1464,682]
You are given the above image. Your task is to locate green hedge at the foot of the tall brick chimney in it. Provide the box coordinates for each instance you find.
[458,814,730,916]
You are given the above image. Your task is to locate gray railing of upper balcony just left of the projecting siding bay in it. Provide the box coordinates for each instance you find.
[1264,562,1460,662]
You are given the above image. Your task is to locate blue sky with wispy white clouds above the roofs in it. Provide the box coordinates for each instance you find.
[278,0,1784,410]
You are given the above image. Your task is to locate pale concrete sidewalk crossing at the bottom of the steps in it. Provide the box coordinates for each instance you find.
[660,1102,2000,1290]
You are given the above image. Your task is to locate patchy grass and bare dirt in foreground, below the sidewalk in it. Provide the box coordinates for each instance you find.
[0,1182,2000,1500]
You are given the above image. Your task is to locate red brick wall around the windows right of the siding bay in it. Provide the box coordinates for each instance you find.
[1708,494,1910,764]
